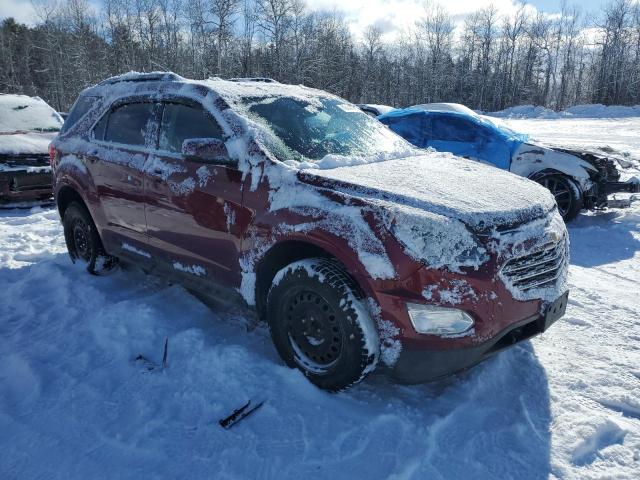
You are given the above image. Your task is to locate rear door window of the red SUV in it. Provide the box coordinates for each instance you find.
[99,103,153,145]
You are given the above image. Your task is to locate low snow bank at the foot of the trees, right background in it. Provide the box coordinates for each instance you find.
[486,104,640,119]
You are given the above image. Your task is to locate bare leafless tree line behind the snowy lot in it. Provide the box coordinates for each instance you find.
[0,0,640,111]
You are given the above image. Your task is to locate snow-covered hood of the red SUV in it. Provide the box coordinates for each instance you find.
[298,152,555,230]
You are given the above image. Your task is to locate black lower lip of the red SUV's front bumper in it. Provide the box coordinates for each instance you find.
[391,292,568,383]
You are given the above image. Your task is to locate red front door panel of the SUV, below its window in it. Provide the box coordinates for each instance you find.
[145,154,248,286]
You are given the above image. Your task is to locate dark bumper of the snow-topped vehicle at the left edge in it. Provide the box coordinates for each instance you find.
[0,168,53,202]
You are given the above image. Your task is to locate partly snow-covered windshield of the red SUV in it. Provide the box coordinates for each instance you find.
[244,97,411,161]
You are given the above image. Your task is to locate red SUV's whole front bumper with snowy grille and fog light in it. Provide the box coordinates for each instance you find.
[376,208,569,383]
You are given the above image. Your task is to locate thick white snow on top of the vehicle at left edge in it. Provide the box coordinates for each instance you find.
[0,94,63,132]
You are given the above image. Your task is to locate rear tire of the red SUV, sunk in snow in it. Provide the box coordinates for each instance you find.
[62,202,117,275]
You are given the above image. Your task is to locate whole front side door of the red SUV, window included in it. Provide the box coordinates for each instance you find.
[144,100,250,287]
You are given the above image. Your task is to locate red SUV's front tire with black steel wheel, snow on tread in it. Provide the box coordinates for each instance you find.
[267,258,380,392]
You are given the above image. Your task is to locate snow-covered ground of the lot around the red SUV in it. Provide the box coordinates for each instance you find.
[0,119,640,479]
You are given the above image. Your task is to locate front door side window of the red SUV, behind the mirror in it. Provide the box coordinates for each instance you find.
[158,103,222,153]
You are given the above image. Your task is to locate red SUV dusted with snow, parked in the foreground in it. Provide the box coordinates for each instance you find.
[51,73,569,391]
